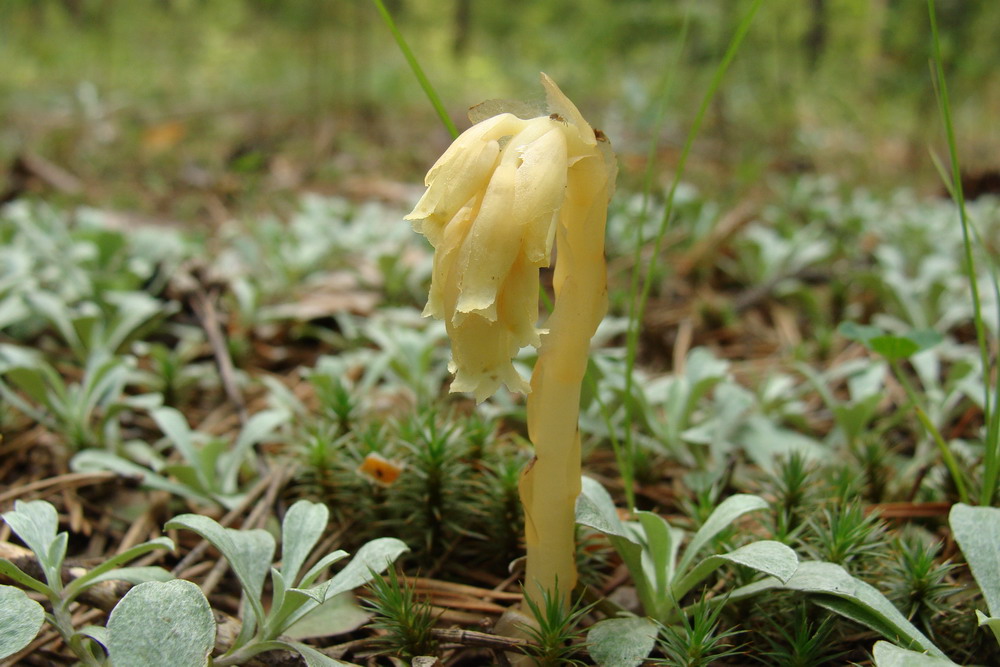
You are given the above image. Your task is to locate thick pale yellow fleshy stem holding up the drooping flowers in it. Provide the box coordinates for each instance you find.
[519,155,611,608]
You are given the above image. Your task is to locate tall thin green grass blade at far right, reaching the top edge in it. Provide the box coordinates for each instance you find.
[927,0,1000,505]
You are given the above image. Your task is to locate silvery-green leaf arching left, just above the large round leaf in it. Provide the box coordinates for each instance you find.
[164,514,274,625]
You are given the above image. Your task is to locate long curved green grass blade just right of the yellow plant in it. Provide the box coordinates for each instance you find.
[616,0,762,507]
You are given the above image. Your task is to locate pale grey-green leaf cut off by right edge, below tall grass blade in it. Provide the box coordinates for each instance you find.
[948,503,1000,617]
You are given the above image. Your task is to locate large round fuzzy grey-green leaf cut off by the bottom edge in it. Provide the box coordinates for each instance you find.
[108,579,215,667]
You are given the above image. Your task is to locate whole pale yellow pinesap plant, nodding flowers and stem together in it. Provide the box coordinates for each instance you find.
[407,74,617,603]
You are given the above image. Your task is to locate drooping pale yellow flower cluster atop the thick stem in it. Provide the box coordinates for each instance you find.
[406,74,615,401]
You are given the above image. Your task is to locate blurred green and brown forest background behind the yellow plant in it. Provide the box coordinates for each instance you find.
[0,0,1000,215]
